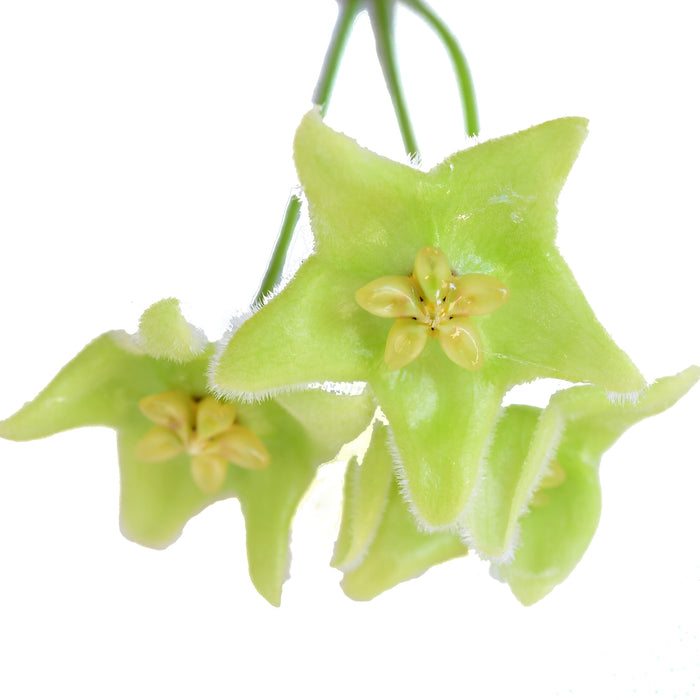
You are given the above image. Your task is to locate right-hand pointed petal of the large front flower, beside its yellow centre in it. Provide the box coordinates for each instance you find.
[482,241,646,393]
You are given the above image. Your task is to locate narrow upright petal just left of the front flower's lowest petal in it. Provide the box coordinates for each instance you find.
[331,424,393,571]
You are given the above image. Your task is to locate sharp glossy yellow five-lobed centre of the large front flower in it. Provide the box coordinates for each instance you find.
[355,247,509,370]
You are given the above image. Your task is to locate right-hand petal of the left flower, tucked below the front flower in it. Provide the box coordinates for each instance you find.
[275,382,376,464]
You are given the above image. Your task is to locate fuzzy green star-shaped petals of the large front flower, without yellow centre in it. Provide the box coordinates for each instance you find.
[213,112,645,528]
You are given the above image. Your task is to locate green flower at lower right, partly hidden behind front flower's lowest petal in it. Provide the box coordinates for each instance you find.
[332,367,700,605]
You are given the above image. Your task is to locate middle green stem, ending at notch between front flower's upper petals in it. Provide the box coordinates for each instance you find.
[369,0,420,160]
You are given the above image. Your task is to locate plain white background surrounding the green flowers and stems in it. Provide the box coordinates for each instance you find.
[0,0,700,699]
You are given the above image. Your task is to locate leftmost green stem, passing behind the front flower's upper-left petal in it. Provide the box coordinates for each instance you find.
[253,0,362,306]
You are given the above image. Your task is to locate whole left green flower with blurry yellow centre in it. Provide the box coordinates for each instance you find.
[0,299,374,605]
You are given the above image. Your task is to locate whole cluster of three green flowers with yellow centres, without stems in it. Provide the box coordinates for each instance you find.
[0,112,700,605]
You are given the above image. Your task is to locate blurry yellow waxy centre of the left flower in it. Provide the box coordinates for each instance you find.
[136,391,270,493]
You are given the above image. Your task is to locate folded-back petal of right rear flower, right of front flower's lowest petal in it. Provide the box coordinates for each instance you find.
[462,406,564,559]
